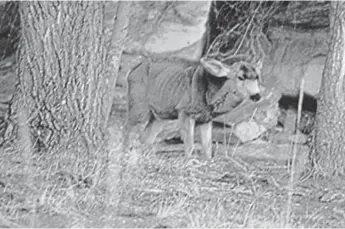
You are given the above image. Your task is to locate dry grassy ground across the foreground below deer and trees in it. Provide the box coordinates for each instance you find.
[0,87,345,228]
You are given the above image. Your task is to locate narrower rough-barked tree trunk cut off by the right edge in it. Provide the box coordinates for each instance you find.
[315,1,345,176]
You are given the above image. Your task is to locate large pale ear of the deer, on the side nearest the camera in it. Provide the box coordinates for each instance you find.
[200,58,230,77]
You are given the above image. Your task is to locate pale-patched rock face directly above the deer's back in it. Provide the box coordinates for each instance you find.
[111,1,211,85]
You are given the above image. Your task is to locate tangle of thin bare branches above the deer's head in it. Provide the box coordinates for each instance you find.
[205,2,279,64]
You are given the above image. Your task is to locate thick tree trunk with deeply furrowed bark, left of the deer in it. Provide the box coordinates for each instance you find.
[7,1,109,161]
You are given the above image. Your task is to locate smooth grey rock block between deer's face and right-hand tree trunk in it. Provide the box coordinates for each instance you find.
[263,28,328,97]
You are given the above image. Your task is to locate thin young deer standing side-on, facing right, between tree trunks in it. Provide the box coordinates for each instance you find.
[126,57,262,159]
